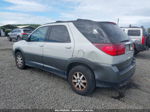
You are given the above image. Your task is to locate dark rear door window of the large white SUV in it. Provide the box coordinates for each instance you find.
[48,25,70,43]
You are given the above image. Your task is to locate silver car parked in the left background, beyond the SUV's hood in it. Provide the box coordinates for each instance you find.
[8,28,32,41]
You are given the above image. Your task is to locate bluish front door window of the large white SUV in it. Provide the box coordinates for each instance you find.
[29,26,48,42]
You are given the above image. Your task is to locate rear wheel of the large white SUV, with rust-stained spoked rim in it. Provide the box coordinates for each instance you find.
[68,65,96,96]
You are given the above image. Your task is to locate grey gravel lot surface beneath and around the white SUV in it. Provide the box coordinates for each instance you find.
[0,38,150,109]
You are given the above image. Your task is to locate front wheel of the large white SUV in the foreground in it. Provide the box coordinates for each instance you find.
[15,52,26,69]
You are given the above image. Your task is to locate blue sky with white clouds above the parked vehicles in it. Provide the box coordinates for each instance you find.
[0,0,150,26]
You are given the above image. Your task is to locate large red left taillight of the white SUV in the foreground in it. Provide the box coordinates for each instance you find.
[94,43,125,56]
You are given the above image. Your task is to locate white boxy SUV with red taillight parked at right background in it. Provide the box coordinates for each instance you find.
[121,27,149,54]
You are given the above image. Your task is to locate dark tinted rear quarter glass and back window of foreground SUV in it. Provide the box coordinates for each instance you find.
[74,21,129,43]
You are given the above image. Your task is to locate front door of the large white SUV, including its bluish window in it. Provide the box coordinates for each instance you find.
[25,26,48,68]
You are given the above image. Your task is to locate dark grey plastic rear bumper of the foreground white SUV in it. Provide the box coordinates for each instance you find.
[94,59,136,87]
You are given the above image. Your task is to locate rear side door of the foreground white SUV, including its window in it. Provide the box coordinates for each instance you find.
[43,24,74,74]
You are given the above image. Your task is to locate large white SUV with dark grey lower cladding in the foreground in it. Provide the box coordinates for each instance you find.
[13,19,135,95]
